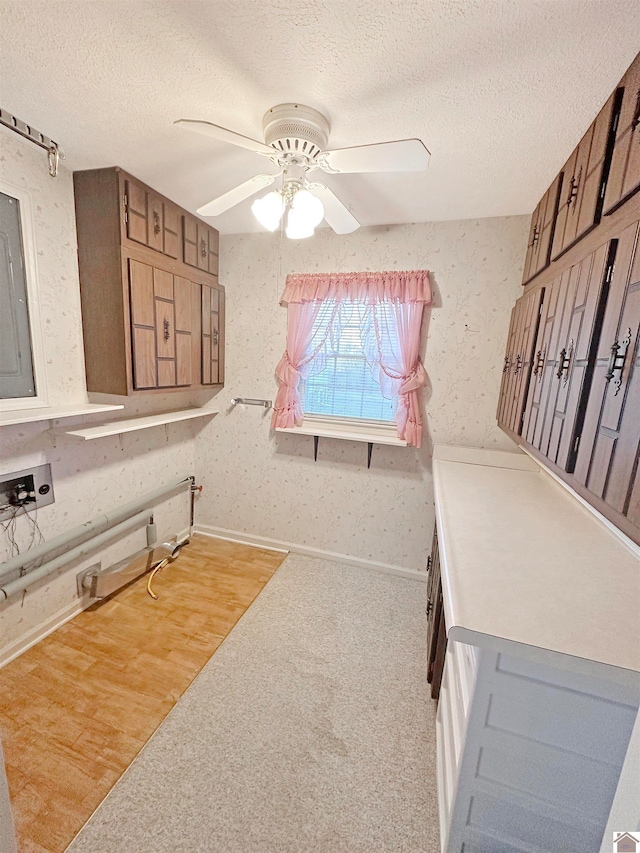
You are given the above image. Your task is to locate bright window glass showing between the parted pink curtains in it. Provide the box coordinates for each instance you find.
[303,301,397,422]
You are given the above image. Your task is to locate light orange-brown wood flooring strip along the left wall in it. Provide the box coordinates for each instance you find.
[0,536,285,853]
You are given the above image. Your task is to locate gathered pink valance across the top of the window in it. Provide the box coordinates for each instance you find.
[280,270,431,305]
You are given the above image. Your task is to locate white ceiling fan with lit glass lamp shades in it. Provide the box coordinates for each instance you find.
[174,104,430,239]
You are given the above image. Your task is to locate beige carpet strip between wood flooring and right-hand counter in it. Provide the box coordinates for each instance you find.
[68,555,440,853]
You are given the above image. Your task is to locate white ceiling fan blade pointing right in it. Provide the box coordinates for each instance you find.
[318,139,431,173]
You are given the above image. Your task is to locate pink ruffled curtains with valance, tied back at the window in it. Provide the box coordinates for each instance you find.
[271,270,431,447]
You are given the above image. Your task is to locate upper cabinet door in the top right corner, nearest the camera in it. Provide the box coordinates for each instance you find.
[604,54,640,215]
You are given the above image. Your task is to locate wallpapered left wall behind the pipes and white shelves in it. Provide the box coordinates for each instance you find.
[0,135,202,662]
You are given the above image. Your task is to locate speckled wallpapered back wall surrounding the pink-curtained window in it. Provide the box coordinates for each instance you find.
[196,217,529,570]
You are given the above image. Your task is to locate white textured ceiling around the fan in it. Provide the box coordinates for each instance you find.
[0,0,640,232]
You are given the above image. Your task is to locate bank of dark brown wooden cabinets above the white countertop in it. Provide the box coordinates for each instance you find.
[498,51,640,543]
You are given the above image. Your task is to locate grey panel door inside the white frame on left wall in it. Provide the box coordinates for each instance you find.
[0,193,36,399]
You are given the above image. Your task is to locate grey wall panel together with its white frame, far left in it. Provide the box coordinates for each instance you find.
[0,183,46,408]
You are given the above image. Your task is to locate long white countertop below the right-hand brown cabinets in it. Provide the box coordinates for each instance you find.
[433,446,640,673]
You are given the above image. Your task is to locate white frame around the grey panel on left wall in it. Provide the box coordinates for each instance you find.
[0,179,49,412]
